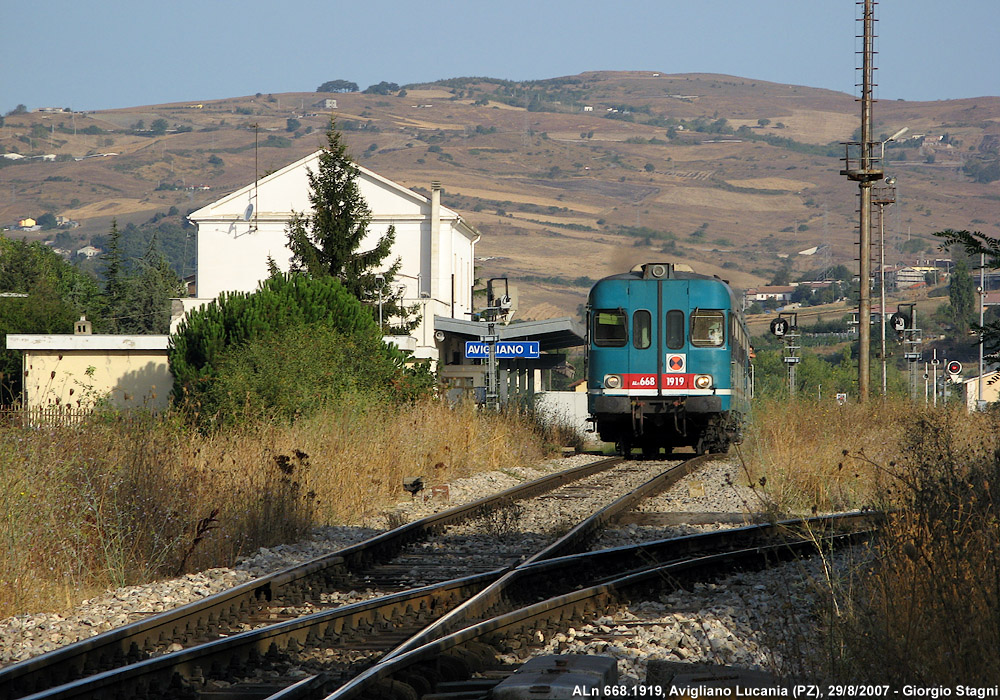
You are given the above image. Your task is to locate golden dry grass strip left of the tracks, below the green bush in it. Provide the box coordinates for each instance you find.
[0,402,543,616]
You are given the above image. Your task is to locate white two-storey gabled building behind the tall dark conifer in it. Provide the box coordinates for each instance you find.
[190,151,479,360]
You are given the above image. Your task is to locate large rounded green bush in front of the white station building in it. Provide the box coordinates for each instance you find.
[169,274,429,421]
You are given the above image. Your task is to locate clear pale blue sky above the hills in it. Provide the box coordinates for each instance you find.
[0,0,1000,113]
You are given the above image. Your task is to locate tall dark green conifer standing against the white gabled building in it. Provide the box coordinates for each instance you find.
[286,120,418,330]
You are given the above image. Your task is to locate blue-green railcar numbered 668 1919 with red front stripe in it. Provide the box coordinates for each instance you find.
[587,263,753,457]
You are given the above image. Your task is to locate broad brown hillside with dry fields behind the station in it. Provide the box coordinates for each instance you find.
[0,72,1000,317]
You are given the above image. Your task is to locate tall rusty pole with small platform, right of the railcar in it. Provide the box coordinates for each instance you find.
[840,0,883,403]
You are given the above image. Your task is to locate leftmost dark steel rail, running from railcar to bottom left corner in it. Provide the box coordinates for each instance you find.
[0,457,622,700]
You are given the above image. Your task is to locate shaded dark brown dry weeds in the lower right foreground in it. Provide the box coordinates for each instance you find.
[828,411,1000,687]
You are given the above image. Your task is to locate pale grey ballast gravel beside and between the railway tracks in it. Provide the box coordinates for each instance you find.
[0,448,836,680]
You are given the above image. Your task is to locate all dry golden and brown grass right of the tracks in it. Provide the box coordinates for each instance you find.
[743,402,1000,687]
